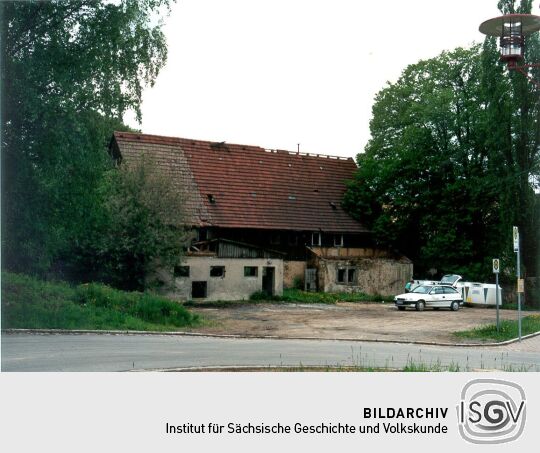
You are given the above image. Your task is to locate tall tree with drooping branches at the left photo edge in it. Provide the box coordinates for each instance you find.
[0,0,173,272]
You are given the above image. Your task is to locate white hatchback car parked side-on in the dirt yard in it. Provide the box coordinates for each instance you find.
[394,285,463,311]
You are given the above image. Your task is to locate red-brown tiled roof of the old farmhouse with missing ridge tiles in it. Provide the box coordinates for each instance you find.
[111,132,367,233]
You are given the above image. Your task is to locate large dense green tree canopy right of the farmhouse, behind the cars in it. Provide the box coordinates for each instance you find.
[345,1,540,286]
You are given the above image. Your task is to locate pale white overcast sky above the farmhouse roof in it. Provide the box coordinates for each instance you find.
[124,0,508,157]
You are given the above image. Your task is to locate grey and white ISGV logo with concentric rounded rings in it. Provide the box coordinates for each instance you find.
[457,379,527,444]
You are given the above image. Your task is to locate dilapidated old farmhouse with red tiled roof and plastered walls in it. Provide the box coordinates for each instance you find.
[111,132,412,300]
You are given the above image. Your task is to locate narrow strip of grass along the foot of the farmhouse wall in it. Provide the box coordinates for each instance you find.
[184,289,394,308]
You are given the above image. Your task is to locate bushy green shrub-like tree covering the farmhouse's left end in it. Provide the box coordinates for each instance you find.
[87,155,190,290]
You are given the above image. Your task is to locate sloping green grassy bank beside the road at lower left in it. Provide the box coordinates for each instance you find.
[2,272,200,331]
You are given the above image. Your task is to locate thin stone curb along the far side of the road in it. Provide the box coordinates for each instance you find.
[2,329,540,348]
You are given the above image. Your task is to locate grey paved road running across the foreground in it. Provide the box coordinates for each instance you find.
[1,333,540,371]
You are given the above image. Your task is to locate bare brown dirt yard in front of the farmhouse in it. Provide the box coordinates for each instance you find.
[192,303,517,343]
